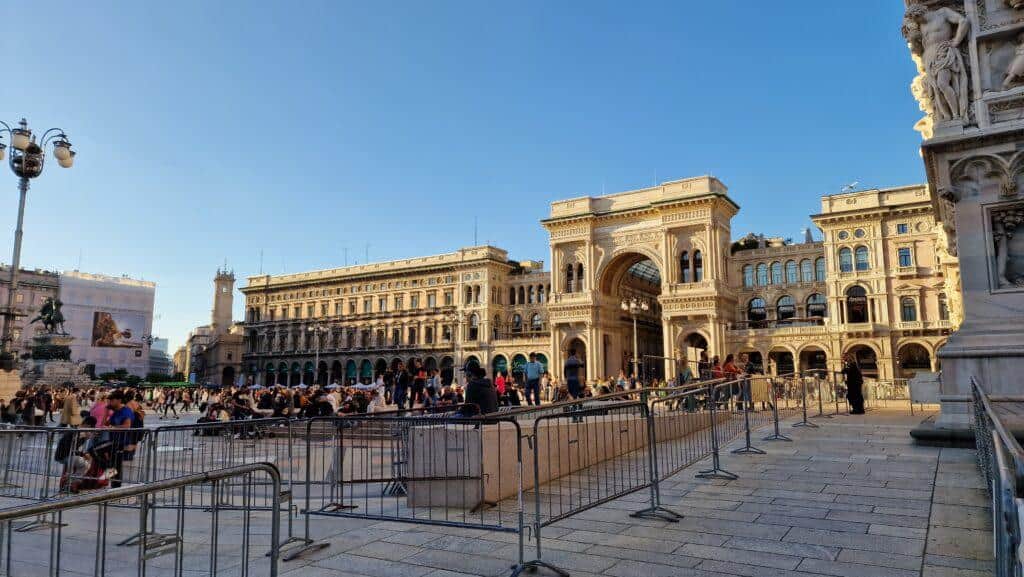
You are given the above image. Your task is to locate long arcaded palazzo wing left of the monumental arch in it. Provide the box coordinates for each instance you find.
[242,246,551,384]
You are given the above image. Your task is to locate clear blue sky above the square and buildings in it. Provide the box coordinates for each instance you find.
[0,0,924,347]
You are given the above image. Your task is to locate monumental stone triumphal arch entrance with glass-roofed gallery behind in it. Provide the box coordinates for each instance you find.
[543,176,739,379]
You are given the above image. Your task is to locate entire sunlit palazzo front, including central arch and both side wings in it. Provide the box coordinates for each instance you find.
[241,176,962,384]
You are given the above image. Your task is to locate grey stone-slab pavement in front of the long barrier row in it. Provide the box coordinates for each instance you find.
[282,408,992,577]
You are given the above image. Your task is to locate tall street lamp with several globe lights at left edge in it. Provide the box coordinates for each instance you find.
[0,118,76,369]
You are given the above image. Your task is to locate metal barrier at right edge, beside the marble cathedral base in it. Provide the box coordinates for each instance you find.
[971,378,1024,577]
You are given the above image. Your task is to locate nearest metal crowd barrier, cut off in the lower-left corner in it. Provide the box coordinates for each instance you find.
[0,463,287,577]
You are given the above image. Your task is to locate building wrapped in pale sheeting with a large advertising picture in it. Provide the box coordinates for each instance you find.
[59,271,157,377]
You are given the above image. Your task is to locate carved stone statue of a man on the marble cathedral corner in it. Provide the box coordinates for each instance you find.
[903,4,971,122]
